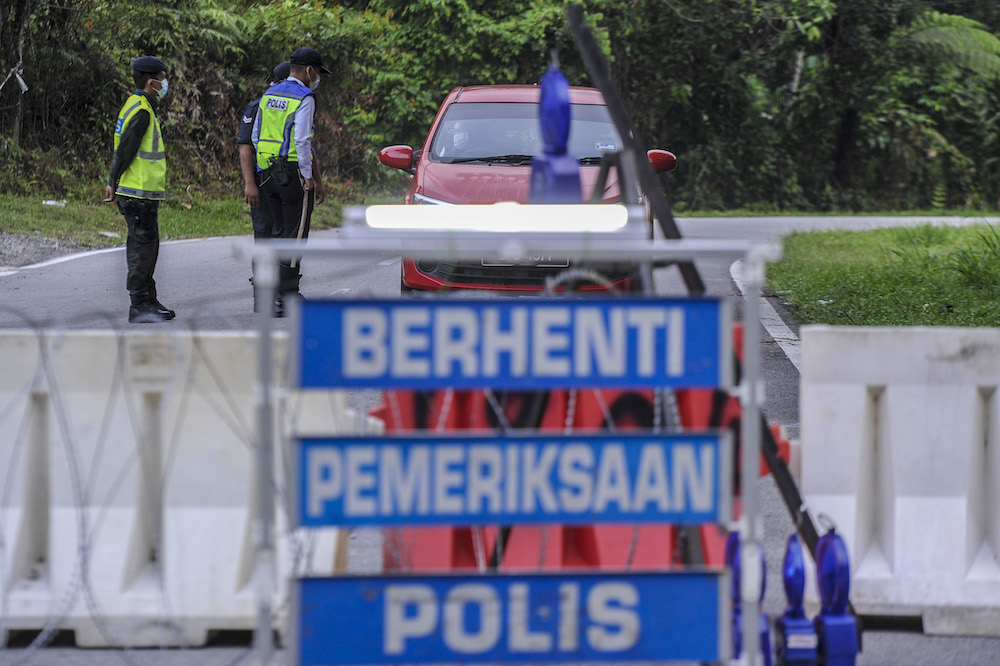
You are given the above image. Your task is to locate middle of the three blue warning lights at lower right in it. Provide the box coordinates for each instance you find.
[774,534,819,666]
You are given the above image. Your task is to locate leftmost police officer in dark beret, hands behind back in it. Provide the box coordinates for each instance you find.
[104,56,175,324]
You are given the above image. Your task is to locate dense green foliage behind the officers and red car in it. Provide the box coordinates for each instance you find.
[0,0,1000,211]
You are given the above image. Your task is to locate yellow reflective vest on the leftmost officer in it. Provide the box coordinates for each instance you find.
[115,91,167,200]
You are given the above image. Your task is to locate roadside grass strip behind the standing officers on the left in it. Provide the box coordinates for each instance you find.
[0,187,402,248]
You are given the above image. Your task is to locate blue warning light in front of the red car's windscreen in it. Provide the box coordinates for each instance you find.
[528,64,583,203]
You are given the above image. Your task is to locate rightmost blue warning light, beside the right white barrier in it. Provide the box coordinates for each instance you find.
[813,529,858,666]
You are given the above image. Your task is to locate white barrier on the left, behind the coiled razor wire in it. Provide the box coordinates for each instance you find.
[0,332,369,647]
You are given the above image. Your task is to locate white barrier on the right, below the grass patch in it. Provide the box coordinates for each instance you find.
[800,326,1000,636]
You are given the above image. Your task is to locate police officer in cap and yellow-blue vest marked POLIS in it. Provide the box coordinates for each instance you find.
[251,47,331,317]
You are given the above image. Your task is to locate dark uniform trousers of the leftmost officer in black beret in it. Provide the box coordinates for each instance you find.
[117,196,160,305]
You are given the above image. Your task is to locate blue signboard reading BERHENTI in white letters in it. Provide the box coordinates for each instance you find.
[296,298,732,389]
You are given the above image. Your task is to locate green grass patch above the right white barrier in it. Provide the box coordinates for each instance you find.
[768,224,1000,327]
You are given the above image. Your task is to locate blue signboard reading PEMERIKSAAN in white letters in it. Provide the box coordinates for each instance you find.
[296,432,732,527]
